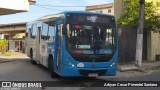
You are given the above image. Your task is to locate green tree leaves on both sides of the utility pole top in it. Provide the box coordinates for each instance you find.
[117,0,160,32]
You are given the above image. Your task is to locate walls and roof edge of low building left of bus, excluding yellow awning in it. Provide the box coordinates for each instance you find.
[0,22,26,51]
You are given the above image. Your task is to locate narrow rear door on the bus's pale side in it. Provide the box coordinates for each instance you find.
[36,26,41,64]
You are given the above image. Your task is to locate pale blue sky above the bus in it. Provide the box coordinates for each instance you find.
[0,0,114,24]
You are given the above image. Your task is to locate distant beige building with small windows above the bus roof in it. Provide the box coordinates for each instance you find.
[86,3,114,15]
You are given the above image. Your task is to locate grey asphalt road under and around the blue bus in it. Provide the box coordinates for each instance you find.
[0,59,160,90]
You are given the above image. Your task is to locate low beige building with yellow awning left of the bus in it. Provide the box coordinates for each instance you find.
[0,22,26,52]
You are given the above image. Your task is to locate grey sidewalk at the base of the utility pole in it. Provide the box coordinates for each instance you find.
[112,61,160,78]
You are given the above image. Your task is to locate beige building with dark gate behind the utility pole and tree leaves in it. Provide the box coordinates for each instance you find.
[114,0,160,61]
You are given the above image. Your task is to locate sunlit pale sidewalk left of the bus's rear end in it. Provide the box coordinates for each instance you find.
[0,52,29,63]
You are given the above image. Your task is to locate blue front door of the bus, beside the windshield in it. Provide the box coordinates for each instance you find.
[54,21,63,72]
